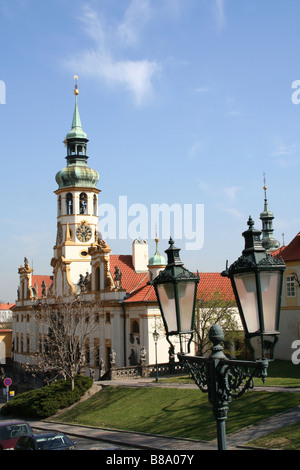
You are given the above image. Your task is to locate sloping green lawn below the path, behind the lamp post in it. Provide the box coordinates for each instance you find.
[57,387,300,440]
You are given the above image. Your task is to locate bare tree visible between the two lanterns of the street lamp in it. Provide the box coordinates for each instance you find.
[195,290,240,356]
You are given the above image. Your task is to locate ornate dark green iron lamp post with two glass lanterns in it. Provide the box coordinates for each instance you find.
[152,222,285,450]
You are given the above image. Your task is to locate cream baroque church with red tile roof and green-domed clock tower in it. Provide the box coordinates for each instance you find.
[13,82,237,380]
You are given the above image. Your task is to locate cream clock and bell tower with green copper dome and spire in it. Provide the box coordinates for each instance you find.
[51,75,100,296]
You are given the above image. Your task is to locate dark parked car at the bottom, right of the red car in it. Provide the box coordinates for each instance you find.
[15,432,76,450]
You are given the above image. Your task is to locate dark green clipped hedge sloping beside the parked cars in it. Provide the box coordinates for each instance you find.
[0,375,93,419]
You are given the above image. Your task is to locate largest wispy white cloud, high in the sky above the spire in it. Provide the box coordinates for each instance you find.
[65,0,161,105]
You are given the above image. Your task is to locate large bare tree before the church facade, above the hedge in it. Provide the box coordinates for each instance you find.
[26,297,99,390]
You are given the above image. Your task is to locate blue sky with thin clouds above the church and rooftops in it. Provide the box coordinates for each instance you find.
[0,0,300,302]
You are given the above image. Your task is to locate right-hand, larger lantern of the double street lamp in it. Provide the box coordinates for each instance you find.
[222,217,285,359]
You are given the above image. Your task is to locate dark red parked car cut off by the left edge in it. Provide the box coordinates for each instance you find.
[0,419,33,450]
